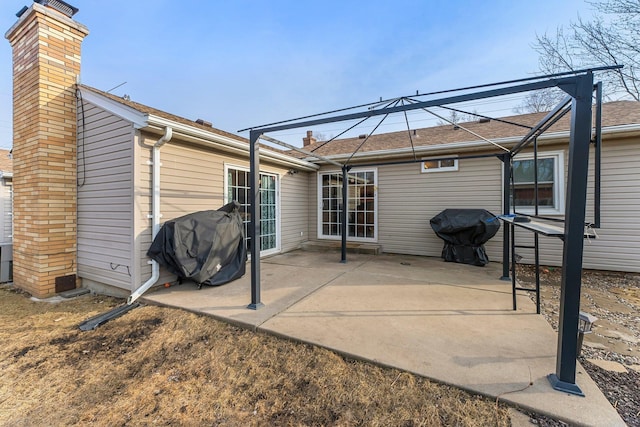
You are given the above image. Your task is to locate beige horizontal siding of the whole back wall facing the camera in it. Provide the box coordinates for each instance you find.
[356,135,640,272]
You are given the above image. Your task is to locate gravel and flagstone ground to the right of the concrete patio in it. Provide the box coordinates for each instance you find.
[516,266,640,427]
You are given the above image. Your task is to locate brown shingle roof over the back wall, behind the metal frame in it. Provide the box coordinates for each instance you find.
[305,101,640,156]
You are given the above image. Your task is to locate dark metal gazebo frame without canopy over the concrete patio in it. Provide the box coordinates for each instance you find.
[242,66,621,396]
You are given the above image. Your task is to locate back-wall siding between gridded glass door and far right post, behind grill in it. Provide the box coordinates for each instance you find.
[378,159,502,261]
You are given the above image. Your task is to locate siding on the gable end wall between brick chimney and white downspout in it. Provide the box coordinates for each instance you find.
[78,103,135,290]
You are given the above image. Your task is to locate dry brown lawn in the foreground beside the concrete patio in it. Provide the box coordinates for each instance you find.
[0,286,510,426]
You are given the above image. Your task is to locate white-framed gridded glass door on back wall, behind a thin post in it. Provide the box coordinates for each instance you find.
[318,170,377,240]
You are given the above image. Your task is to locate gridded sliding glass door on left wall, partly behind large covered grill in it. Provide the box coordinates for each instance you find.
[225,167,278,252]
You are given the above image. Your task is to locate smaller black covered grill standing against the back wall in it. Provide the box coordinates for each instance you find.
[430,209,500,266]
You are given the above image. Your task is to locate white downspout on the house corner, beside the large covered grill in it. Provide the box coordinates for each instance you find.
[127,126,173,305]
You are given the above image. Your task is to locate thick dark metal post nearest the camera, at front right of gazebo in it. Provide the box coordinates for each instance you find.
[549,72,593,396]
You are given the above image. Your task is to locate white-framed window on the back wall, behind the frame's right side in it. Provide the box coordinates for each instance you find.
[510,151,564,215]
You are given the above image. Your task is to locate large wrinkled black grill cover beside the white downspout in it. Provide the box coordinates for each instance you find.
[147,202,247,286]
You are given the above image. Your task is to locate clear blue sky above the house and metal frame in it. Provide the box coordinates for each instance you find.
[0,0,591,148]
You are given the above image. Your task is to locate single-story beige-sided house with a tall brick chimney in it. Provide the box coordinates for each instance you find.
[6,1,640,297]
